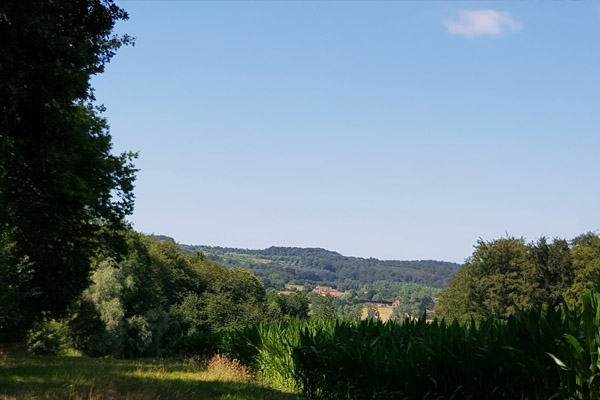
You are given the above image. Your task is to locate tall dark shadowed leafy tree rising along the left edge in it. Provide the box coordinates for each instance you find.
[0,0,136,334]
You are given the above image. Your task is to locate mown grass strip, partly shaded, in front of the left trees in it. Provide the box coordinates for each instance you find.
[0,349,299,400]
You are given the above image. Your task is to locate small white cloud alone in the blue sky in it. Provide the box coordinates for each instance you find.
[443,10,523,37]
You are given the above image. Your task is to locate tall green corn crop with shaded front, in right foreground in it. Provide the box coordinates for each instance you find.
[217,292,600,400]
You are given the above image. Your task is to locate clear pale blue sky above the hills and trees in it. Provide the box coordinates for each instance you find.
[92,1,600,263]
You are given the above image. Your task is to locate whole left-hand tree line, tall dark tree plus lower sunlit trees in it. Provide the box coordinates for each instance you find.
[0,0,308,346]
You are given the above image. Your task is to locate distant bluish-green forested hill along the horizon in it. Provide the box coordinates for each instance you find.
[180,244,460,289]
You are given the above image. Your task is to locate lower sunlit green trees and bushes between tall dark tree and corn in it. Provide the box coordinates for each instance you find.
[69,231,274,357]
